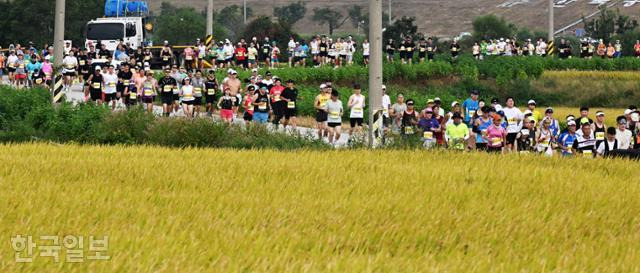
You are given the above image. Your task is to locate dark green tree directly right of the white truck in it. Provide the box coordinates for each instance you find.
[154,2,206,44]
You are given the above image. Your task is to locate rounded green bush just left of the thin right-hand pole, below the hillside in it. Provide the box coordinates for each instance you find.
[472,14,517,41]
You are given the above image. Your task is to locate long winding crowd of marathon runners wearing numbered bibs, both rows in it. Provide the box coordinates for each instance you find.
[0,36,640,153]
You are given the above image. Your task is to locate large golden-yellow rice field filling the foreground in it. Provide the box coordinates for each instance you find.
[0,144,640,273]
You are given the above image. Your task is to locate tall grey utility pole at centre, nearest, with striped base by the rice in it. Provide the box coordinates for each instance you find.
[369,0,382,148]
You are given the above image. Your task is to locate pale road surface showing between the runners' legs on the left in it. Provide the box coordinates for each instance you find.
[2,76,349,148]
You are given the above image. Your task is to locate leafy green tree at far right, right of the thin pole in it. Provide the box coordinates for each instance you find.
[582,5,638,41]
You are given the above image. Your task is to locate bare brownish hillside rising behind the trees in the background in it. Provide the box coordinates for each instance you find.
[148,0,640,37]
